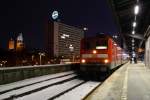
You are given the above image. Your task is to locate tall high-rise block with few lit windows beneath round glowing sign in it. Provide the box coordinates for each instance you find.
[45,22,84,58]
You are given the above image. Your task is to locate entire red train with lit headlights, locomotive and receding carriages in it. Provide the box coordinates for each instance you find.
[80,34,129,73]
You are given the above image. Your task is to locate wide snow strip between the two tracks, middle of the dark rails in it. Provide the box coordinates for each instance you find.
[17,79,83,100]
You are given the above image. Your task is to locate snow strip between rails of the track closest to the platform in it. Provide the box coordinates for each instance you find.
[55,82,100,100]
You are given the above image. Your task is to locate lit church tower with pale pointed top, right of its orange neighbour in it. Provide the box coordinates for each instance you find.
[16,33,24,51]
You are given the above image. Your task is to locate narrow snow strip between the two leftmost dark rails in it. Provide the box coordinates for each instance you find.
[0,71,76,100]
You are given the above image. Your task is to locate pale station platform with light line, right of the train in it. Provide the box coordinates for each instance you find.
[85,62,150,100]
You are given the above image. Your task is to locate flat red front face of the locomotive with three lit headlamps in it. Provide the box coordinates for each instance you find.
[80,37,110,72]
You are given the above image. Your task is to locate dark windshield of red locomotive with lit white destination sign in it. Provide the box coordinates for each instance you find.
[83,38,108,50]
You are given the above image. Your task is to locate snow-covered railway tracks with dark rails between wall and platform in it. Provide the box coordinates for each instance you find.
[0,72,100,100]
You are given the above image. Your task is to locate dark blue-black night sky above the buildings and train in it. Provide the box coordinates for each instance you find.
[0,0,118,49]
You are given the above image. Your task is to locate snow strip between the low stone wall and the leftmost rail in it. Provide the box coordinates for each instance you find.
[0,71,74,92]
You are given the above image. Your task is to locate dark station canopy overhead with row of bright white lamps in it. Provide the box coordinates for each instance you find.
[108,0,150,51]
